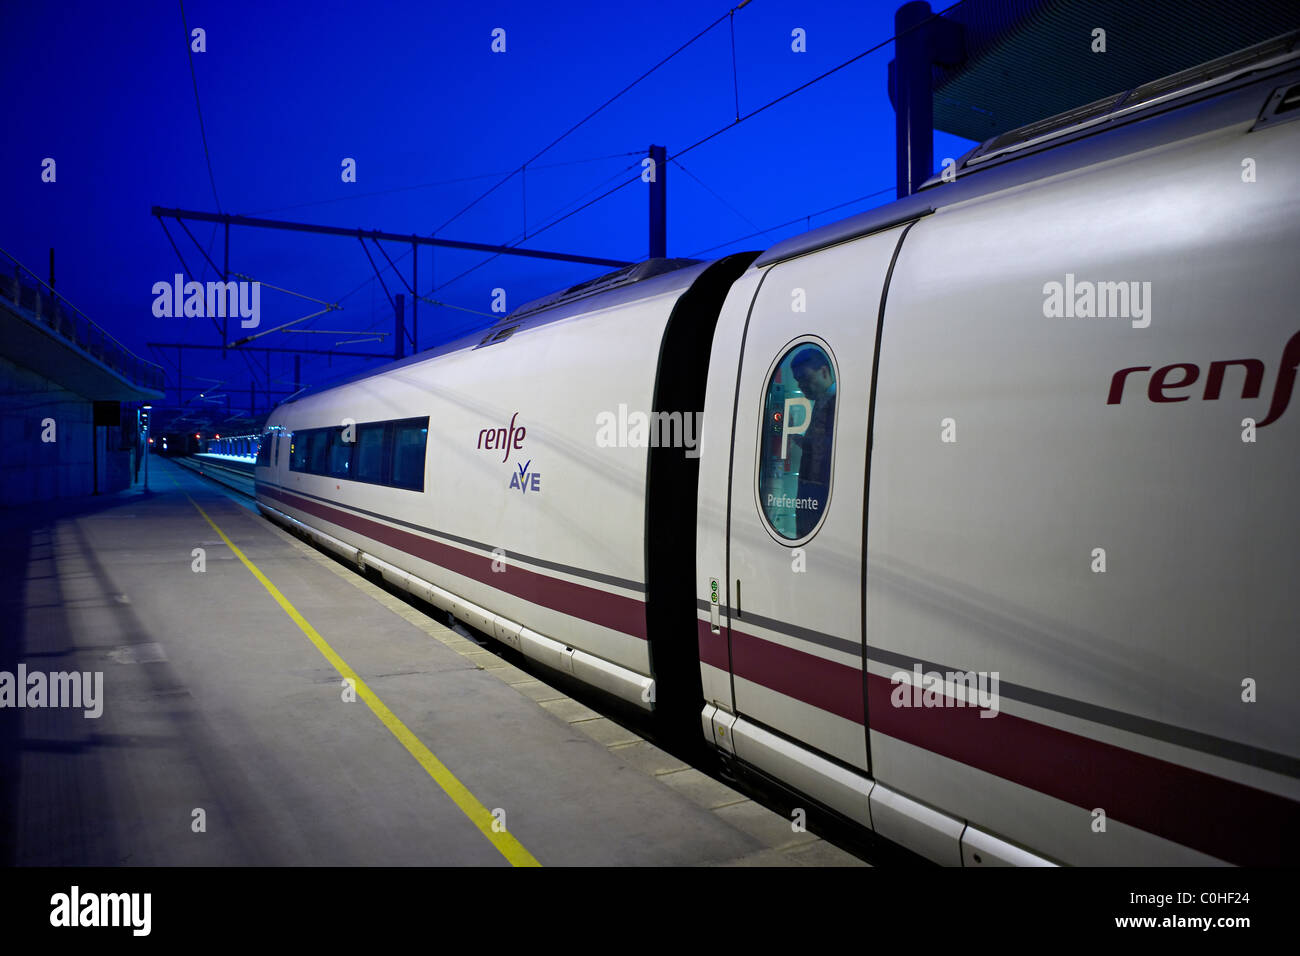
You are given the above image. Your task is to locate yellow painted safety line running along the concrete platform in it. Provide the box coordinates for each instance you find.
[173,479,541,866]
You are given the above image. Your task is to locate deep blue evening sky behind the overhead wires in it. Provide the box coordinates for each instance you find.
[0,0,970,411]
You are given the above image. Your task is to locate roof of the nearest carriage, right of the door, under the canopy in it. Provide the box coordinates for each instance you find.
[754,30,1300,267]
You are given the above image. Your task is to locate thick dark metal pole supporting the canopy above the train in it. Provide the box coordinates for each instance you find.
[894,0,935,199]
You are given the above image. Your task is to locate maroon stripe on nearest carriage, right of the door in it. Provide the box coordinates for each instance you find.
[867,674,1300,866]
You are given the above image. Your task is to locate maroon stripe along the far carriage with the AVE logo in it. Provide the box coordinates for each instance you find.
[259,485,646,640]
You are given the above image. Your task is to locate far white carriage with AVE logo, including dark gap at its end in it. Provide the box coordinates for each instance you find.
[257,254,754,721]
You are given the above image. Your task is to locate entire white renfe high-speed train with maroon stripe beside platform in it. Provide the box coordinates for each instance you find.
[256,35,1300,865]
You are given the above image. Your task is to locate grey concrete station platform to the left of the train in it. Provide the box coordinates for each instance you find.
[0,459,861,866]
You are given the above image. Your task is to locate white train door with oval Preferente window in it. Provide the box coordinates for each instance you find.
[725,229,901,822]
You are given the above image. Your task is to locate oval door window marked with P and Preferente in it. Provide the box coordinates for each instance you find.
[758,342,836,541]
